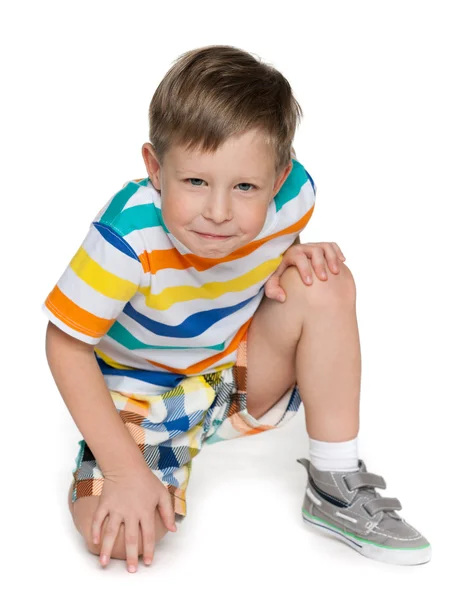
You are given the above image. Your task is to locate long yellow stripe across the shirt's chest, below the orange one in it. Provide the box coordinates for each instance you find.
[145,256,282,310]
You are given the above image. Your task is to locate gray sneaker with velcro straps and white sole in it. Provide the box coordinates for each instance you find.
[297,458,431,565]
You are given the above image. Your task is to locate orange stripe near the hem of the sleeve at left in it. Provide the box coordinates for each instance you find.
[45,285,114,337]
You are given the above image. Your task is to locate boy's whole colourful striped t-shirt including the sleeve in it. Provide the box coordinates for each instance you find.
[43,158,316,395]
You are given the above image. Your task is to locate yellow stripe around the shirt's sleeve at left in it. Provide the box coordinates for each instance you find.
[70,248,137,301]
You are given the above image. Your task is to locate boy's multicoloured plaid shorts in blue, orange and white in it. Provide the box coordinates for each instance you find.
[72,336,301,517]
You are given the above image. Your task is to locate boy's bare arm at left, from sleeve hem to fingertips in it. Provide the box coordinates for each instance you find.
[46,322,177,571]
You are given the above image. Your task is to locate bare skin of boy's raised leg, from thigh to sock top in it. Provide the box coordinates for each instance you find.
[247,264,361,442]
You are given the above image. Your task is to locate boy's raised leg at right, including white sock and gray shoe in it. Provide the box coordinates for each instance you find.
[247,264,431,565]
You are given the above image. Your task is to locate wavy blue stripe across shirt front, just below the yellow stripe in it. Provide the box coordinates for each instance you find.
[123,292,259,338]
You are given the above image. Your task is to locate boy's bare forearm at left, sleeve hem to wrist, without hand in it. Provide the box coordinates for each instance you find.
[46,322,146,473]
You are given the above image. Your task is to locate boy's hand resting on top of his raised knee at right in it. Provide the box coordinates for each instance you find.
[264,242,346,302]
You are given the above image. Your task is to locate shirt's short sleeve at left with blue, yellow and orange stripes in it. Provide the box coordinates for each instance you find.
[42,222,143,345]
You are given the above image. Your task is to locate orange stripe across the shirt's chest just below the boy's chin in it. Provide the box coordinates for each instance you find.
[139,204,315,275]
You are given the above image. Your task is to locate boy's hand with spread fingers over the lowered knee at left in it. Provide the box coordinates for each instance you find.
[92,465,177,572]
